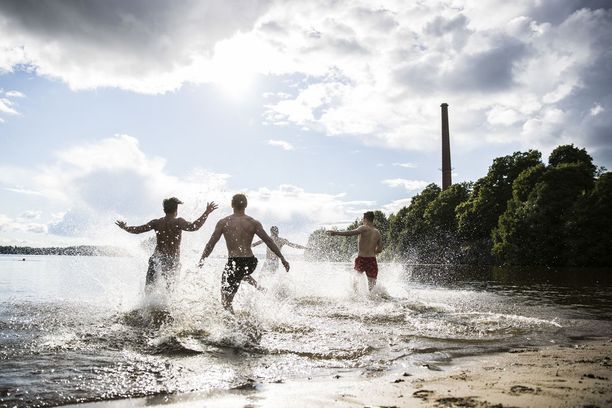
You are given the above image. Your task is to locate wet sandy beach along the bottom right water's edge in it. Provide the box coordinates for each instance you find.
[68,339,612,408]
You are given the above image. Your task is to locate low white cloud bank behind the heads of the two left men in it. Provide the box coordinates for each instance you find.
[0,135,376,243]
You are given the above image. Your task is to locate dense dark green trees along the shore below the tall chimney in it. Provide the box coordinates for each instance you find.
[306,145,612,266]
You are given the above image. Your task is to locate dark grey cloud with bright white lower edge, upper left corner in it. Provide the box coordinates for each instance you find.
[0,0,269,93]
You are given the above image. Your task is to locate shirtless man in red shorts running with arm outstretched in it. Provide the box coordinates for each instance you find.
[327,211,382,290]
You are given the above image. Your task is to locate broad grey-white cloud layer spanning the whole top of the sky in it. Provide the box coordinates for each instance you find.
[0,0,612,155]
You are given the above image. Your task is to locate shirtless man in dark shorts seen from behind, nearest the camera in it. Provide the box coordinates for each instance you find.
[199,194,289,313]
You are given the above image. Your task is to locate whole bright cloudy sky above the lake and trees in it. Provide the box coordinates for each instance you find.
[0,0,612,250]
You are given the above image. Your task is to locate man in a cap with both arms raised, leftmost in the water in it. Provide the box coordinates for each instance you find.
[115,197,217,292]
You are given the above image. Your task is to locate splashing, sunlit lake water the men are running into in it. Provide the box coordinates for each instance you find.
[0,256,612,407]
